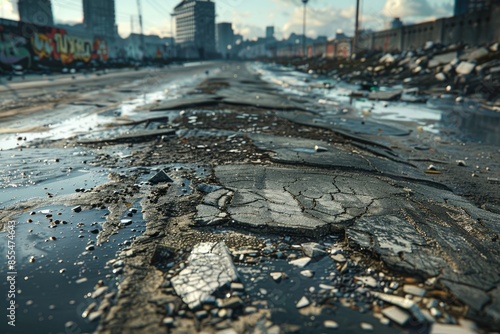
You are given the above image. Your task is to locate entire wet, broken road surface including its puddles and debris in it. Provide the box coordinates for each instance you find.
[0,63,500,333]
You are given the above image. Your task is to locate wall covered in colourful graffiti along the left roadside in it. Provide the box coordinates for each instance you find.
[0,19,108,69]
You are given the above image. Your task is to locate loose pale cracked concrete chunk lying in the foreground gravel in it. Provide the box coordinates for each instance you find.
[171,242,238,309]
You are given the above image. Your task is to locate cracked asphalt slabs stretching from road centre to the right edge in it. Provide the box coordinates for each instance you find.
[196,165,500,320]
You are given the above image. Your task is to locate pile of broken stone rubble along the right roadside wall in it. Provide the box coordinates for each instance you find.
[282,43,500,107]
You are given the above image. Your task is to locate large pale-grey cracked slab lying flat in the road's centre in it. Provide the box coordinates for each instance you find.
[196,166,405,235]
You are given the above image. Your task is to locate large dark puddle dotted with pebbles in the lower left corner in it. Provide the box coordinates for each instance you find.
[0,203,145,333]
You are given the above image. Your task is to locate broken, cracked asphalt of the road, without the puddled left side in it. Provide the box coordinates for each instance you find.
[0,63,500,333]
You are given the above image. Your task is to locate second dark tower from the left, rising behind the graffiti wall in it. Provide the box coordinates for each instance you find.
[83,0,117,40]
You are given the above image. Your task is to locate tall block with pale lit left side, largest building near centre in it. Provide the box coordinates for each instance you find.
[174,0,216,58]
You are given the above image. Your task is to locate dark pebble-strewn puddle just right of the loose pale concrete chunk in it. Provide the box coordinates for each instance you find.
[237,258,400,334]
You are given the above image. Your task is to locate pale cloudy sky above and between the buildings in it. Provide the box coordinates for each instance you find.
[0,0,454,39]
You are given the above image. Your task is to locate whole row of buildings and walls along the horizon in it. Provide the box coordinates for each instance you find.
[0,0,500,70]
